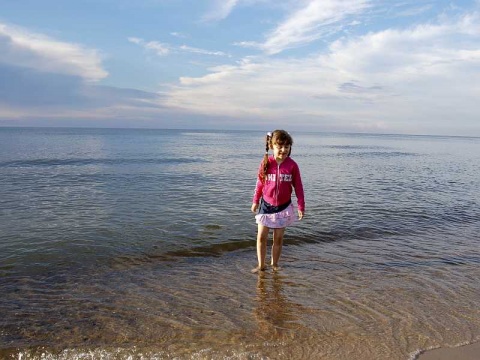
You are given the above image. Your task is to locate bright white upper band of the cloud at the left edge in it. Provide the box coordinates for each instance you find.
[0,23,108,81]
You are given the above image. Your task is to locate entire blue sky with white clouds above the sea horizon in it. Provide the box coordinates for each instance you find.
[0,0,480,136]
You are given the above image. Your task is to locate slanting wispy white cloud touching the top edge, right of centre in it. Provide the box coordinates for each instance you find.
[262,0,369,54]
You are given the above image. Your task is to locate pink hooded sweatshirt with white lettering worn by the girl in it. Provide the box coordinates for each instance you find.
[253,156,305,212]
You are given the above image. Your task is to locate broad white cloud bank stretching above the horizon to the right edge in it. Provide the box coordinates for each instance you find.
[162,14,480,131]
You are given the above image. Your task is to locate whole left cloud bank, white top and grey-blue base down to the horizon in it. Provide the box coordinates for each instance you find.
[0,24,161,120]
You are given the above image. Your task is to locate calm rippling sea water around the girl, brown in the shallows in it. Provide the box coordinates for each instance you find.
[0,128,480,360]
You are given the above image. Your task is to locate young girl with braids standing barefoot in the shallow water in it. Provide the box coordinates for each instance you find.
[252,130,305,273]
